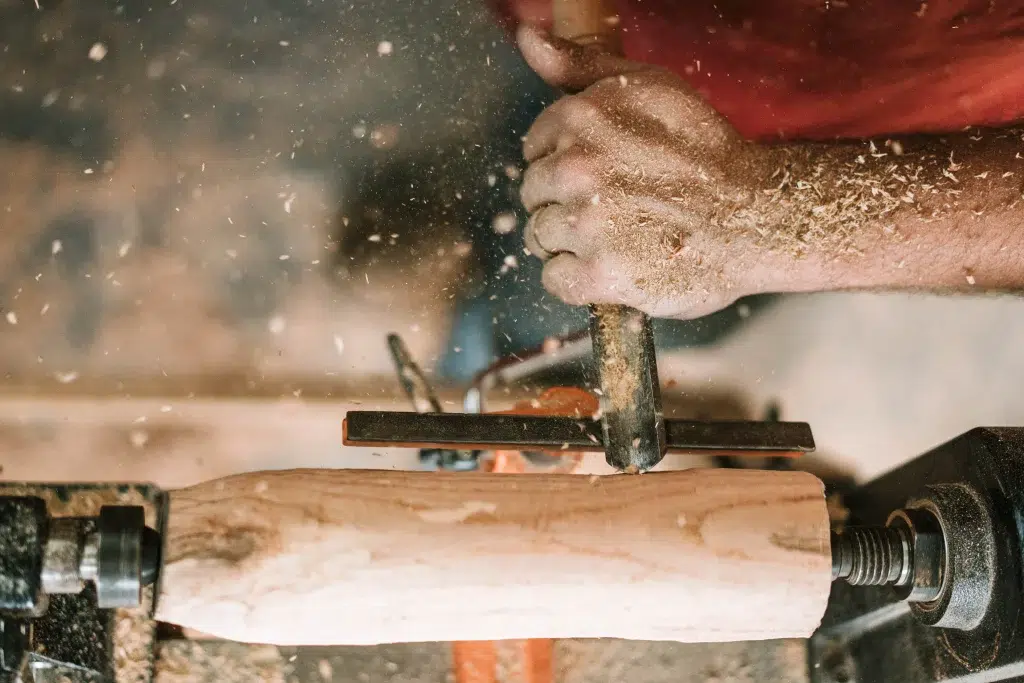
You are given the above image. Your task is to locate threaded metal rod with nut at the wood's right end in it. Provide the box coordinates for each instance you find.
[831,526,913,586]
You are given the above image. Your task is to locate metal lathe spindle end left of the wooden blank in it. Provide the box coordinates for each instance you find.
[0,483,167,683]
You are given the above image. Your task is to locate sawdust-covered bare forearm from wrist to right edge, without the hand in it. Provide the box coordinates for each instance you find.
[732,129,1024,292]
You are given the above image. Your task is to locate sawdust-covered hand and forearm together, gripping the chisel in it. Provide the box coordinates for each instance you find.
[519,23,1024,317]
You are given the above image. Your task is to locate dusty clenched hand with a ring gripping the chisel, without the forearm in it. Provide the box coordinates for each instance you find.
[519,28,777,317]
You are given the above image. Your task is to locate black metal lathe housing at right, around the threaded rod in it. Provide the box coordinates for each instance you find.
[808,428,1024,683]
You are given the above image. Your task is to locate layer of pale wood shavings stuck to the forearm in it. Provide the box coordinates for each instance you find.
[724,129,1021,259]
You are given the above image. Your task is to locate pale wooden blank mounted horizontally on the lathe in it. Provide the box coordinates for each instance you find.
[158,469,831,645]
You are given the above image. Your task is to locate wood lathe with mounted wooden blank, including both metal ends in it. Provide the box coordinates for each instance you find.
[0,428,1024,683]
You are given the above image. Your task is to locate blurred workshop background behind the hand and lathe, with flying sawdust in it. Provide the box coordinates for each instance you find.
[0,0,1024,681]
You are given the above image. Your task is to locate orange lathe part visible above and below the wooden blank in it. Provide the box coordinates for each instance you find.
[452,387,600,683]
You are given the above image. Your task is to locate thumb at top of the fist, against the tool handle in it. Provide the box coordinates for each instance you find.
[516,24,649,92]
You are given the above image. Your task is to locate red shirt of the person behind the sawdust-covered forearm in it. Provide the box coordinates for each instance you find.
[493,0,1024,139]
